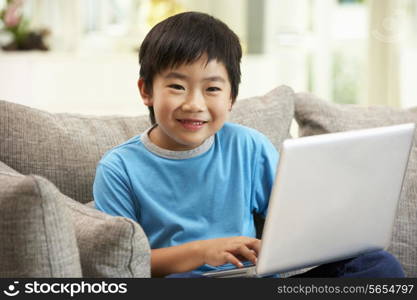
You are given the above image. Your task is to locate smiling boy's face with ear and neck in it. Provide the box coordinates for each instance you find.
[138,56,232,151]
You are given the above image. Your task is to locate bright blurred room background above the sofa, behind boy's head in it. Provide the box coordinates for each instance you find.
[0,0,417,115]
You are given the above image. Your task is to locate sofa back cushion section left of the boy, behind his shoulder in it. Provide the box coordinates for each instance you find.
[0,101,149,203]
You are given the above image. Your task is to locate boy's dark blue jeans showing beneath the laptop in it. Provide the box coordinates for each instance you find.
[166,250,405,278]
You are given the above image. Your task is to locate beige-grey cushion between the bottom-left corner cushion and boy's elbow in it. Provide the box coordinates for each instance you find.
[61,198,150,278]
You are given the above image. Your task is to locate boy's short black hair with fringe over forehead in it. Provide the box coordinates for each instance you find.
[139,12,242,124]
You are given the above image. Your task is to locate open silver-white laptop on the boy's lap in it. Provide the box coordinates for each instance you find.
[203,123,415,277]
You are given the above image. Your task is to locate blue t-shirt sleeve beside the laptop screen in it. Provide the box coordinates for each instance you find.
[252,136,279,218]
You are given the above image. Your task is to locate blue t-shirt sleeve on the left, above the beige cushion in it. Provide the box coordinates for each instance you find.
[93,163,138,222]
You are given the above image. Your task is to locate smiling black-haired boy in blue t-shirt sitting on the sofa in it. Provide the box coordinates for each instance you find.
[94,12,404,276]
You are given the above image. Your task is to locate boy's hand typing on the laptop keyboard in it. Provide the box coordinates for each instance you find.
[201,236,261,268]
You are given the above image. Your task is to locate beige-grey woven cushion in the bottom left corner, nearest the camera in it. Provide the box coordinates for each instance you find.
[0,162,82,278]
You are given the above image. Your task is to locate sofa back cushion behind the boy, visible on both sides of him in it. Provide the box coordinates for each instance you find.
[0,86,294,203]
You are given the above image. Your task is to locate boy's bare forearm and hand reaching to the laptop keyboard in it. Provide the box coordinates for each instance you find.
[151,236,260,277]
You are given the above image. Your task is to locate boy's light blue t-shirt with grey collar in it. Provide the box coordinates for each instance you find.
[93,123,278,270]
